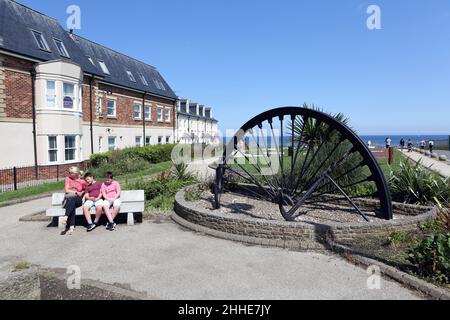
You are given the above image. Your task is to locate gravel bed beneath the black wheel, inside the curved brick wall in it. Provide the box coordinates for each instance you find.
[198,191,405,223]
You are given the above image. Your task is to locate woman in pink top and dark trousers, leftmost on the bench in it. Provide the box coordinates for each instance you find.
[61,167,86,235]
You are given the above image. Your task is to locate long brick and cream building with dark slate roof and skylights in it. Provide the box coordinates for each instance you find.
[0,0,177,168]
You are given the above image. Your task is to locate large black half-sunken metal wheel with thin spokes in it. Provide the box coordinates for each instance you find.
[214,107,393,221]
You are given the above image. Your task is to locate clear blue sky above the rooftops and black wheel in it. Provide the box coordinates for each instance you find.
[19,0,450,134]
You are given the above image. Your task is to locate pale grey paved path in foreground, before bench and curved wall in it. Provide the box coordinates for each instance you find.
[0,198,418,300]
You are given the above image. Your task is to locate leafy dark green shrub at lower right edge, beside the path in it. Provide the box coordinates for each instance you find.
[408,233,450,284]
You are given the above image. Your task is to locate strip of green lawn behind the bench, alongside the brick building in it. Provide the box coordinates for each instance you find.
[0,161,172,203]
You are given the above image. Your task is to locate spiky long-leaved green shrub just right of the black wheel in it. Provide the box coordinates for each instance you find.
[389,160,450,207]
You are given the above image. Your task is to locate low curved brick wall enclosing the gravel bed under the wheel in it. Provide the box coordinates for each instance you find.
[173,186,437,250]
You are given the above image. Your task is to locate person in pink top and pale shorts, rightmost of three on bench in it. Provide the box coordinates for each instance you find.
[100,172,122,231]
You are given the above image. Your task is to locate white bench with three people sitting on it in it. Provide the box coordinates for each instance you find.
[46,190,145,228]
